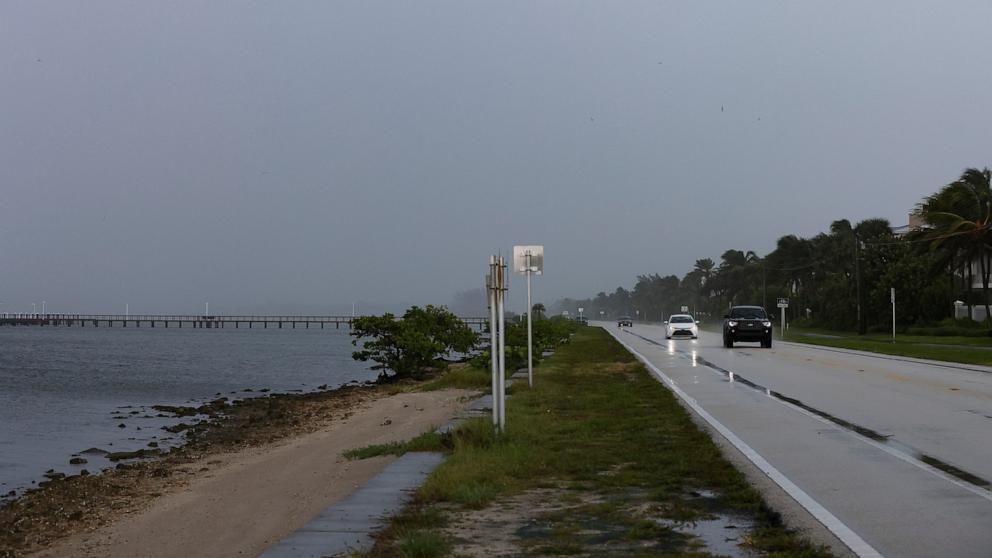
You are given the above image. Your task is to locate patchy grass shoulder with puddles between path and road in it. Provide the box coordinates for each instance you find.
[352,328,830,557]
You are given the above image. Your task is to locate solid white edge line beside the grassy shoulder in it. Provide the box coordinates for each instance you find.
[603,328,882,558]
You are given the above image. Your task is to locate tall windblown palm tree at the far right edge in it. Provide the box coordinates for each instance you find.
[917,168,992,322]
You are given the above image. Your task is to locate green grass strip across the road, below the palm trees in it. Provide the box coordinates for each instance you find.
[785,329,992,366]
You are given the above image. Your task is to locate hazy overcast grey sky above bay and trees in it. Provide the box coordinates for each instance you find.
[0,0,992,313]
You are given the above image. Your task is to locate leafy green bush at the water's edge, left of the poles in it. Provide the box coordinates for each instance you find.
[351,305,479,381]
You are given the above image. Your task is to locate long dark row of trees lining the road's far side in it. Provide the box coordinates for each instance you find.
[555,168,992,333]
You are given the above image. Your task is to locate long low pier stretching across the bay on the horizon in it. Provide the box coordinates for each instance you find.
[0,314,487,331]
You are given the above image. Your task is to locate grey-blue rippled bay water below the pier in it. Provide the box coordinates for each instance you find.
[0,327,375,496]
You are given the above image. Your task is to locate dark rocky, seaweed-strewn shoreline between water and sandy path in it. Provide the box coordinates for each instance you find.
[0,384,391,558]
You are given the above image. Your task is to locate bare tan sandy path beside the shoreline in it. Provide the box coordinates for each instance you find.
[32,390,472,558]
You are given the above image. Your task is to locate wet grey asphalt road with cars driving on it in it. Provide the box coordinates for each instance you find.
[603,324,992,558]
